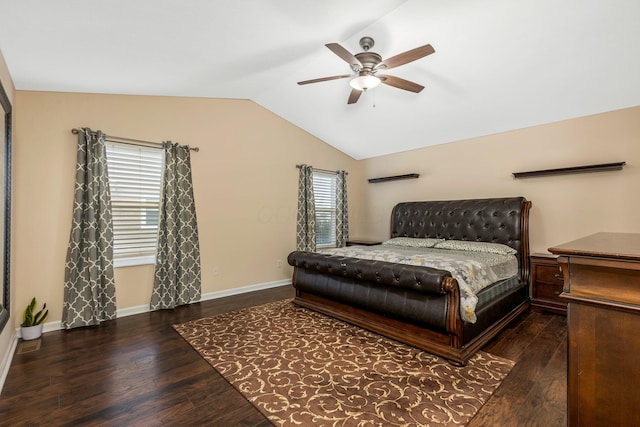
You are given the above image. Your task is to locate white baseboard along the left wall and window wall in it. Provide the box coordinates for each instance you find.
[0,279,291,393]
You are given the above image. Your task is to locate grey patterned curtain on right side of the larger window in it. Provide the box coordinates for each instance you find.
[150,142,202,310]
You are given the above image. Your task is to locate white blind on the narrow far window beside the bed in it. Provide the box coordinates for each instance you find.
[313,171,336,248]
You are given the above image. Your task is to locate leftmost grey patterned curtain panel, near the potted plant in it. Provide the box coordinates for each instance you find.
[62,128,116,329]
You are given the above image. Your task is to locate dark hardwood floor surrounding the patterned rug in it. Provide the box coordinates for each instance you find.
[0,286,567,427]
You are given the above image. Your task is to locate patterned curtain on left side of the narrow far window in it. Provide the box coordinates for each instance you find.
[296,165,316,251]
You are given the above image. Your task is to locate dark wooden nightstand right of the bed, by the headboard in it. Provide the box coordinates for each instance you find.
[530,254,567,314]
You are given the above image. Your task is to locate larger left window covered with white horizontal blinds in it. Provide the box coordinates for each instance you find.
[107,141,164,267]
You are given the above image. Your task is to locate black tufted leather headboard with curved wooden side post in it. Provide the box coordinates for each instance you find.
[391,197,531,282]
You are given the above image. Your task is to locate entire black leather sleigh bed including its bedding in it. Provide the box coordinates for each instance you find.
[288,197,531,365]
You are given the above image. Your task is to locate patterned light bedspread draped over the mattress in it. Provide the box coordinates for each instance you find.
[318,245,518,323]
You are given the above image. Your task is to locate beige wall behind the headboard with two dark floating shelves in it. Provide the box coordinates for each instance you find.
[359,107,640,252]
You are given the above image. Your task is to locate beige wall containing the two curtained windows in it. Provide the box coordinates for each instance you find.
[13,91,364,324]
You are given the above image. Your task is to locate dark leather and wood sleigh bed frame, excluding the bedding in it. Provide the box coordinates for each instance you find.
[288,197,531,365]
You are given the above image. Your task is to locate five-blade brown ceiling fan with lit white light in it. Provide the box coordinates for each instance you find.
[298,36,435,104]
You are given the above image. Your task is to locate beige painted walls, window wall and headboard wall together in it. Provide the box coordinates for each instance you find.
[8,91,640,332]
